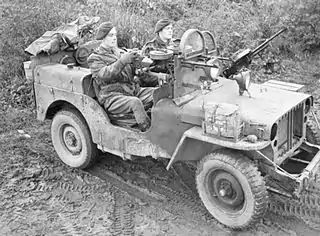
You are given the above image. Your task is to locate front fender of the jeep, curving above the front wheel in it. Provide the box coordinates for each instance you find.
[167,126,270,170]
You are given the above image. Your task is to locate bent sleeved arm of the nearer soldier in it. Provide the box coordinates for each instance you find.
[88,55,125,80]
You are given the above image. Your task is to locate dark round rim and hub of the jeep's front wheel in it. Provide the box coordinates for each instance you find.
[211,171,244,208]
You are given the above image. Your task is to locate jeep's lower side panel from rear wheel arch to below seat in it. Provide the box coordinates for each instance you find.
[35,84,170,158]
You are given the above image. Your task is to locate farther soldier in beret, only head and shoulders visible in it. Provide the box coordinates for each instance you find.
[142,18,175,56]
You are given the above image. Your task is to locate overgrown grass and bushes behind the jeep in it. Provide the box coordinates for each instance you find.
[0,0,320,109]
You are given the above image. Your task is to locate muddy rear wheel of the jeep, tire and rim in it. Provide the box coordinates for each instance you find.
[51,110,98,169]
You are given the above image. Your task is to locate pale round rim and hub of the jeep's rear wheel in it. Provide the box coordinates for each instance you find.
[62,126,82,155]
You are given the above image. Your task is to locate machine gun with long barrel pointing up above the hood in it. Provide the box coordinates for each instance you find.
[222,28,287,78]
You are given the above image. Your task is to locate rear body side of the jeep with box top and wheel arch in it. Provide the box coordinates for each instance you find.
[34,63,110,143]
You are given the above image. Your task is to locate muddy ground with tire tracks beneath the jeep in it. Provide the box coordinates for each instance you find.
[0,60,320,236]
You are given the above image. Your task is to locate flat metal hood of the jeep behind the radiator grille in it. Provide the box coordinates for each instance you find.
[175,78,310,127]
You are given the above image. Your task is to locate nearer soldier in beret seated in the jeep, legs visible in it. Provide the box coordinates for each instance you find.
[88,22,155,131]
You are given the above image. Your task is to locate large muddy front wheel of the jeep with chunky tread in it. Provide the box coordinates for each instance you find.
[196,150,268,229]
